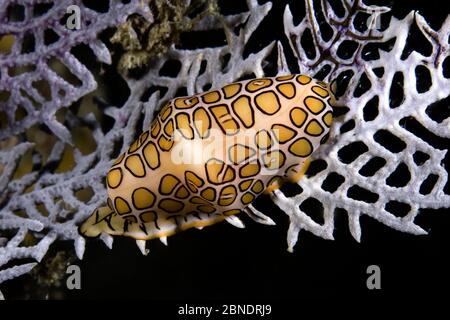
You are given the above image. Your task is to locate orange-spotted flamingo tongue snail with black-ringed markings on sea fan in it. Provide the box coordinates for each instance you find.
[79,75,333,251]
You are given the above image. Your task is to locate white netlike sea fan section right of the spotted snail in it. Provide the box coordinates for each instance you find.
[273,1,450,248]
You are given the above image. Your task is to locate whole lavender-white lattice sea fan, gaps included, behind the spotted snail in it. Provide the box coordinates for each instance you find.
[0,0,450,298]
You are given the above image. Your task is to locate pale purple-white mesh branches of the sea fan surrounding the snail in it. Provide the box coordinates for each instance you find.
[0,0,450,296]
